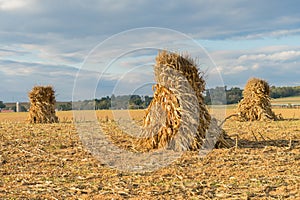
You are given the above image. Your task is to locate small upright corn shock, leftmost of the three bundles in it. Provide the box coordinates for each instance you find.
[28,86,58,123]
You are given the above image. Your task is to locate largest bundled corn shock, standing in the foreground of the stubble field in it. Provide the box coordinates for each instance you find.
[138,51,234,151]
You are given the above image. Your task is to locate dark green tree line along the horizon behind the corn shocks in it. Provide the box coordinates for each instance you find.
[0,86,300,111]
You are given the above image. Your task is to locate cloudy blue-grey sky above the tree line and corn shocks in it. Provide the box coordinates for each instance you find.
[0,0,300,102]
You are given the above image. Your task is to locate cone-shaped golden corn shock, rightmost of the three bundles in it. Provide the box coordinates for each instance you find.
[237,78,278,121]
